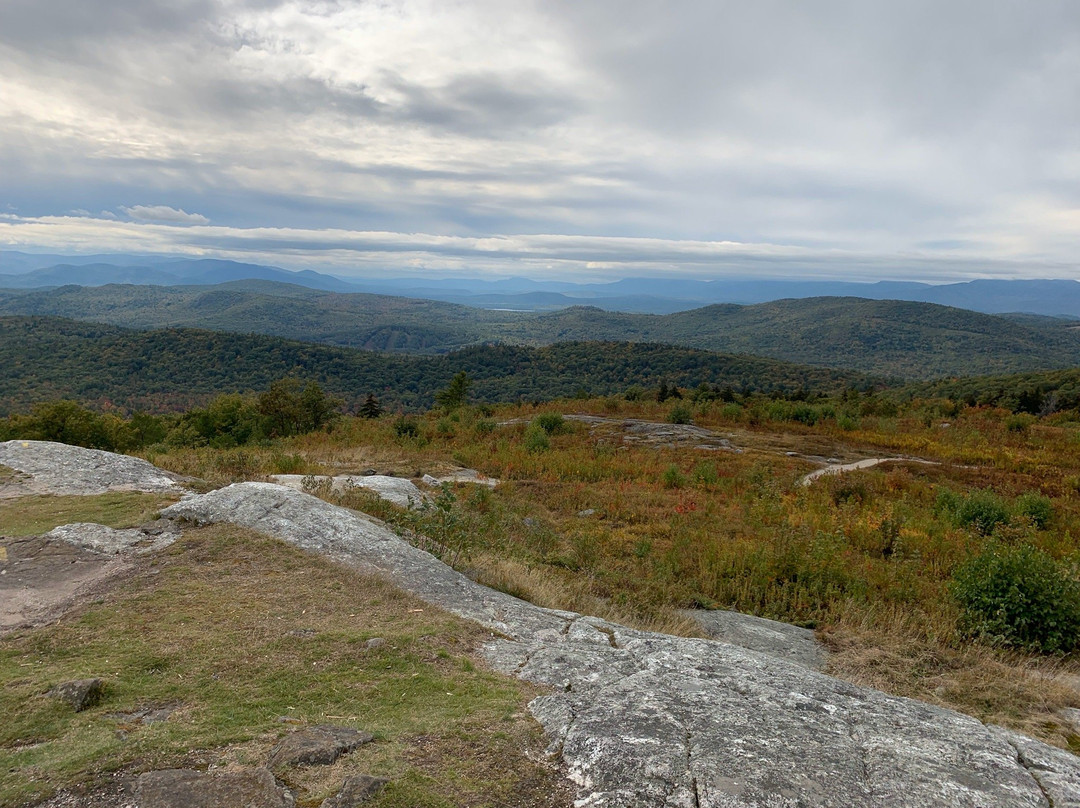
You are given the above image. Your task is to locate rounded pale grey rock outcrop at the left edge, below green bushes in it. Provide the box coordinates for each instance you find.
[0,441,180,496]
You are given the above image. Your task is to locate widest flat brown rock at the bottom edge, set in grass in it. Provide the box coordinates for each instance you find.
[135,767,296,808]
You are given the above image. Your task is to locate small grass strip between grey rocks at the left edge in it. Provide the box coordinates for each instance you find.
[0,491,177,537]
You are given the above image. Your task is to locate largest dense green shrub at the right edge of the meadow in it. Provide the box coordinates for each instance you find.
[949,542,1080,654]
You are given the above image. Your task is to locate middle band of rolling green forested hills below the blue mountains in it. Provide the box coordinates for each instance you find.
[0,280,1080,379]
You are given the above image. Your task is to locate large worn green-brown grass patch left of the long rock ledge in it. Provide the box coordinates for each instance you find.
[0,526,570,806]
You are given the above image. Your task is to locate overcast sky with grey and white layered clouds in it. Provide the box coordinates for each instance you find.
[0,0,1080,281]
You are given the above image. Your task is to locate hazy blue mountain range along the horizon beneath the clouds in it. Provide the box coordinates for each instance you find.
[6,252,1080,319]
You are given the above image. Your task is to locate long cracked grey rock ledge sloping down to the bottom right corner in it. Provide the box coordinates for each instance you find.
[165,483,1080,808]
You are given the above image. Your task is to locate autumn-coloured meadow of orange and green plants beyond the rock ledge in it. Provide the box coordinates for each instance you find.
[143,398,1080,746]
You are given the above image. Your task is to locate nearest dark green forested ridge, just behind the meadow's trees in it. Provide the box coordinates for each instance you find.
[0,317,872,415]
